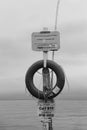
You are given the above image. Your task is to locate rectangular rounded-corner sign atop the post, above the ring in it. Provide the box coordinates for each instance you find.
[32,31,60,51]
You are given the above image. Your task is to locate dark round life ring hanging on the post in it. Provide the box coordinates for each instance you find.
[25,60,65,100]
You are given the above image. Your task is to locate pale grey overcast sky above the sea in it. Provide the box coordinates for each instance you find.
[0,0,87,99]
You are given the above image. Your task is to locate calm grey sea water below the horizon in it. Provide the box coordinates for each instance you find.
[0,100,87,130]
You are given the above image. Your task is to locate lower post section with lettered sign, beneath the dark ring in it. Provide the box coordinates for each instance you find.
[38,100,55,130]
